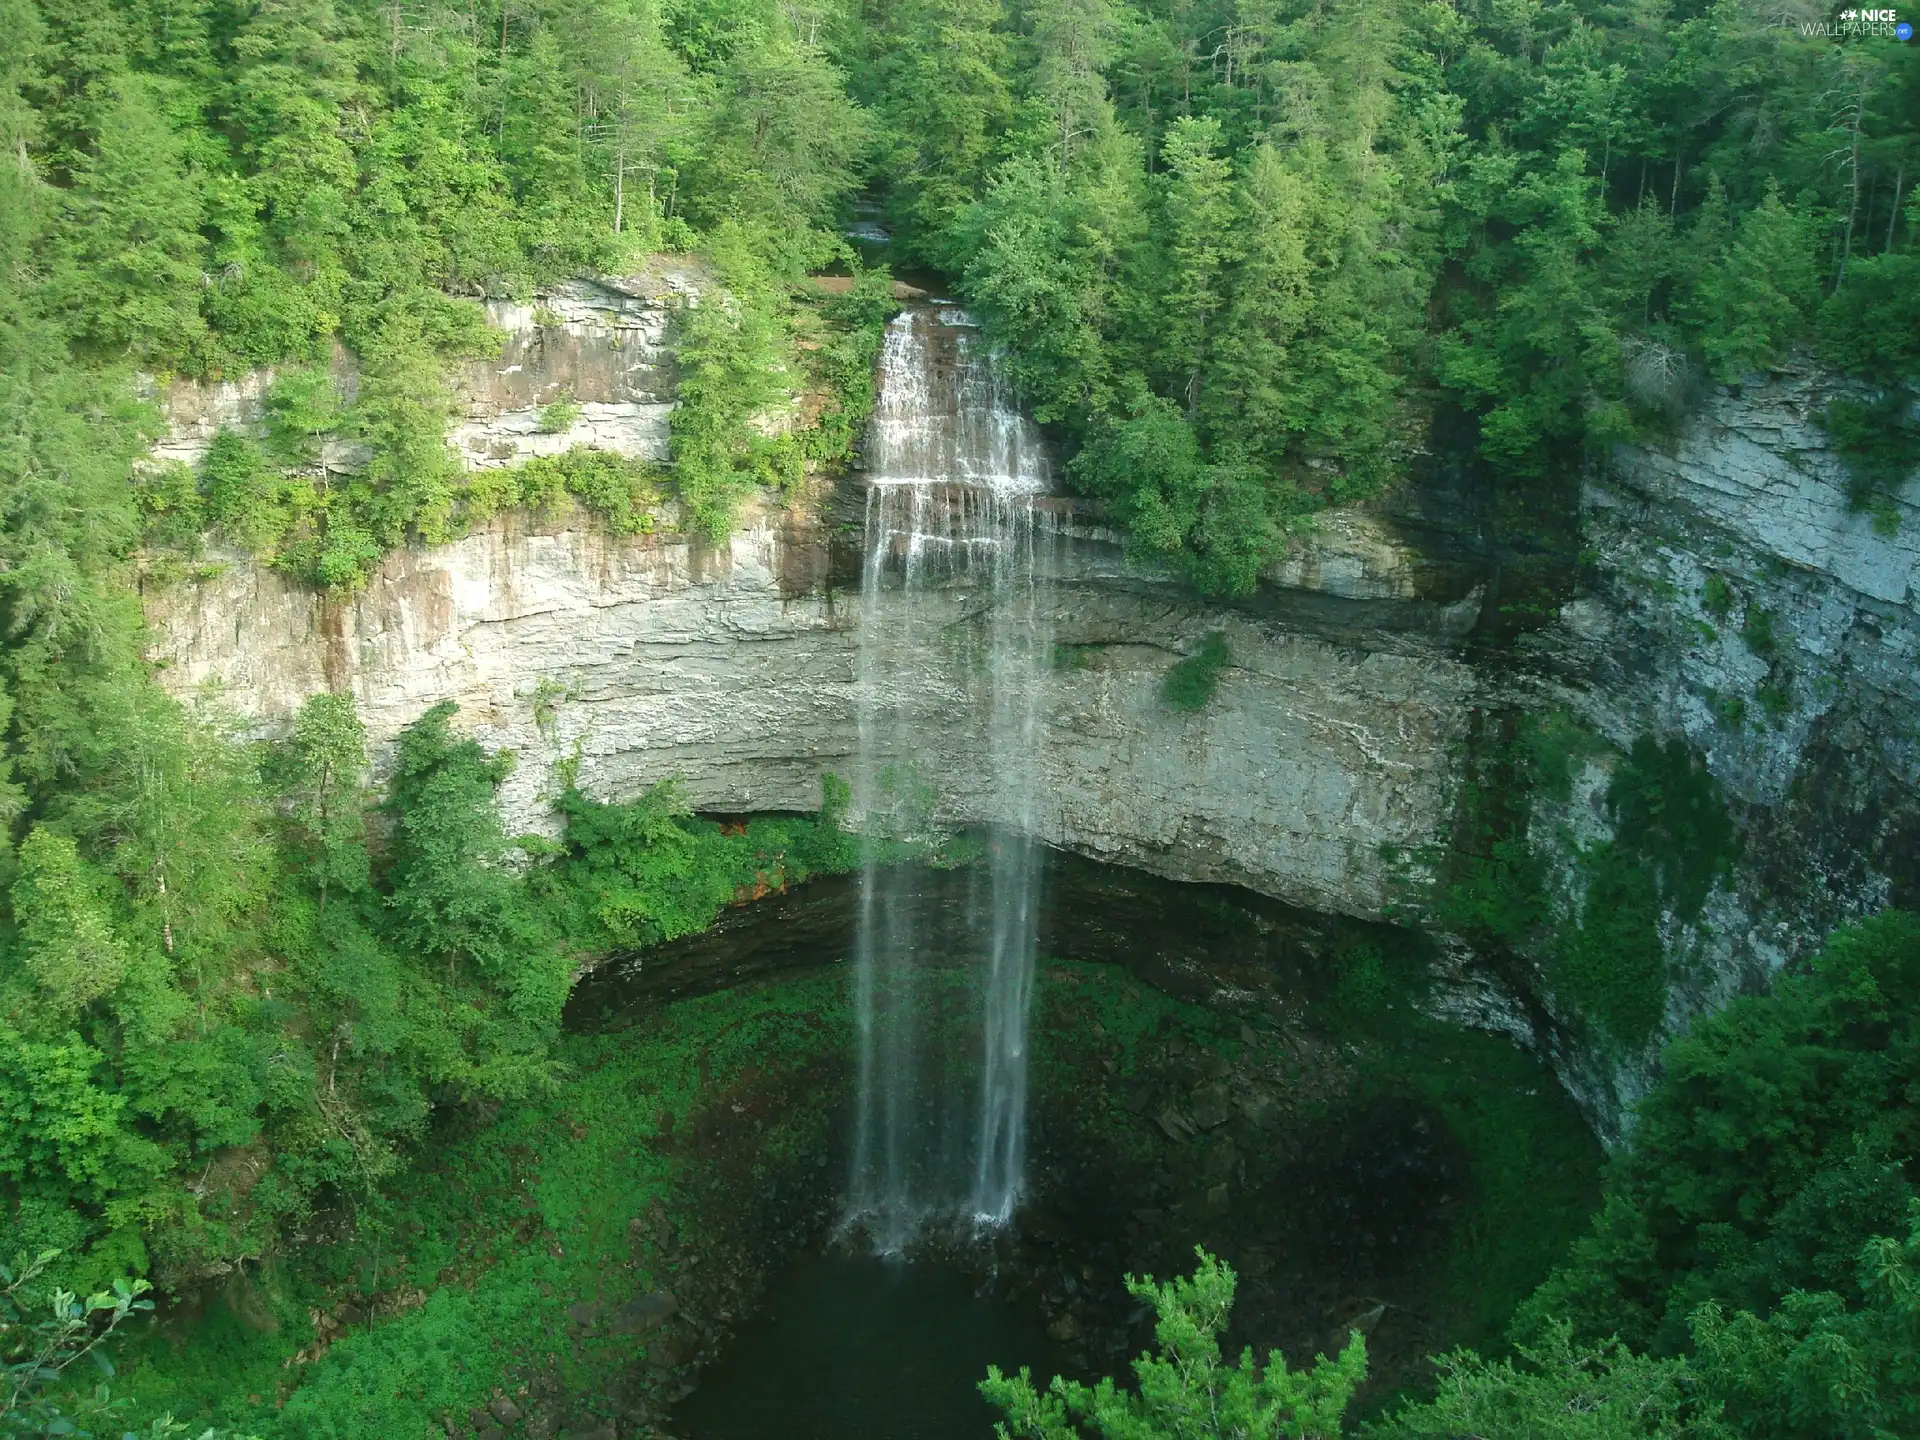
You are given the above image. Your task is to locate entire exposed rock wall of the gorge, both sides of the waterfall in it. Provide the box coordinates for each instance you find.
[146,282,1920,1133]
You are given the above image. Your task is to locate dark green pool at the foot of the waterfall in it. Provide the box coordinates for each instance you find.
[672,1256,1060,1440]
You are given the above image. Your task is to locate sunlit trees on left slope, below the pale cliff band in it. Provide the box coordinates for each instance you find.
[0,652,852,1305]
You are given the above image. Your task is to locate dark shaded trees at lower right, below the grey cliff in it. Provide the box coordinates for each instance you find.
[1528,910,1920,1348]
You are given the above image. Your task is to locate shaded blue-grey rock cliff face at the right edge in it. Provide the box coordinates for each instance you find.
[1519,371,1920,1114]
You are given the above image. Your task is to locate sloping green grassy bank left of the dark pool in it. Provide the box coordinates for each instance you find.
[112,970,849,1440]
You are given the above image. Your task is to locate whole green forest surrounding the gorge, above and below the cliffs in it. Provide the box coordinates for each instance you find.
[0,0,1920,1440]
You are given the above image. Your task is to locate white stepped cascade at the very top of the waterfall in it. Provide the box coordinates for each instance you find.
[866,305,1052,495]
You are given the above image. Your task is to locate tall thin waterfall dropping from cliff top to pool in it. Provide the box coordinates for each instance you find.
[849,305,1054,1250]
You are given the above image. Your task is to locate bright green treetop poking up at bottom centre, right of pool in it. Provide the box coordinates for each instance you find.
[979,1248,1367,1440]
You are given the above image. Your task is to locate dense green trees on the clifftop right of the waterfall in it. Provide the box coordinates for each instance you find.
[845,2,1920,591]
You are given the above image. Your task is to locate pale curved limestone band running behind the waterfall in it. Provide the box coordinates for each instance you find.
[148,507,1475,918]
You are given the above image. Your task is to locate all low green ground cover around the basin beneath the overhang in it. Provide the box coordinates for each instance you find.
[93,917,1597,1440]
